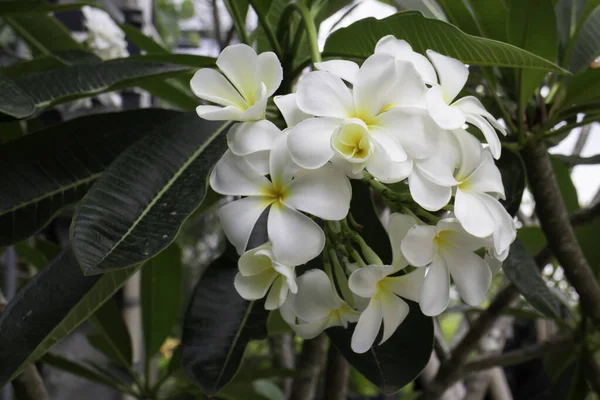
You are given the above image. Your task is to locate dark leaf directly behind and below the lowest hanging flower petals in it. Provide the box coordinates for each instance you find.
[326,301,433,394]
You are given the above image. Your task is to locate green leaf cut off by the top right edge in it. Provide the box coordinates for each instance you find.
[569,5,600,73]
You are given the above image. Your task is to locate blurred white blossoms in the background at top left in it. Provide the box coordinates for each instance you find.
[81,6,129,60]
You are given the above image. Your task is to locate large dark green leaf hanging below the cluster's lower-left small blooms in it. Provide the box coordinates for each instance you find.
[181,255,269,395]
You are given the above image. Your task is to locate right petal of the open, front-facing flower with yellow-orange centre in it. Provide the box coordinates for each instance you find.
[284,165,352,221]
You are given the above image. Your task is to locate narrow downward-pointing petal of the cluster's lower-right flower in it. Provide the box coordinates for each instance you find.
[419,254,450,316]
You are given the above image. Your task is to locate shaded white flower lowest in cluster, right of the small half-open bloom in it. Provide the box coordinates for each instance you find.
[280,269,359,339]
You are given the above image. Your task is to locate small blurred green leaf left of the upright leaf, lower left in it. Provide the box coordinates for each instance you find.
[89,299,133,367]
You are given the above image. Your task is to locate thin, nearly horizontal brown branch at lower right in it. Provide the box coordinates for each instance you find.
[462,337,573,374]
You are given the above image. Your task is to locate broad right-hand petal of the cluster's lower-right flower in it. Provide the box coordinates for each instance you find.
[443,248,492,306]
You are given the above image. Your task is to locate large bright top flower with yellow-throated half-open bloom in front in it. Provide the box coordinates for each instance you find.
[288,54,434,182]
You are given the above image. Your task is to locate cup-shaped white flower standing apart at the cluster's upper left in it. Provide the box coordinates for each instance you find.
[190,44,283,121]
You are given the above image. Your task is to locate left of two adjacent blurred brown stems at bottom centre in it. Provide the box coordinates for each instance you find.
[290,334,327,400]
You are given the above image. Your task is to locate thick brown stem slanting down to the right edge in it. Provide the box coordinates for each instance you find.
[523,142,600,329]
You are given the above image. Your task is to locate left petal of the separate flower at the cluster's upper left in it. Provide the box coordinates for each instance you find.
[190,68,248,109]
